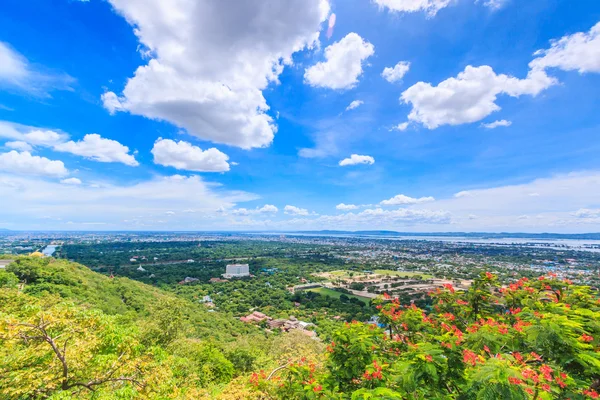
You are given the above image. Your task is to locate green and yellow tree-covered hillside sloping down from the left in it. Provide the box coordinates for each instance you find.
[0,257,319,399]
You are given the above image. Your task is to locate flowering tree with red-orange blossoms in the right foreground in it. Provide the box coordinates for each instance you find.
[252,272,600,399]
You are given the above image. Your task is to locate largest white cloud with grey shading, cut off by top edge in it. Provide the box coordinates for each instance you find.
[102,0,330,149]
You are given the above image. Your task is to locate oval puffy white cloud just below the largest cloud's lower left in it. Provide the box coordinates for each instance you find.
[152,138,229,172]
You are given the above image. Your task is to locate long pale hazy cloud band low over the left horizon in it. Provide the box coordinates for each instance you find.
[0,174,258,230]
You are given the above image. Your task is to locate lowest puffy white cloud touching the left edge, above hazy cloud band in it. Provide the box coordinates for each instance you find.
[0,150,69,177]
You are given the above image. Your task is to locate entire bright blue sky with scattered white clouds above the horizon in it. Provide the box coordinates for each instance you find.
[0,0,600,232]
